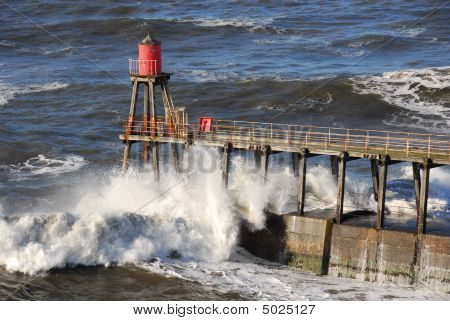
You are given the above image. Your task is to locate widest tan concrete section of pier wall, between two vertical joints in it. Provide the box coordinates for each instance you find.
[329,225,416,285]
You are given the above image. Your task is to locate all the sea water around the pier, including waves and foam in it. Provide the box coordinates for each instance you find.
[0,0,450,300]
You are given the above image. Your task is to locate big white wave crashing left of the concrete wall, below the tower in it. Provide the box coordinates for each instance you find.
[0,146,237,274]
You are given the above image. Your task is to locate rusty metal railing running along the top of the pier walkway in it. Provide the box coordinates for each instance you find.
[124,118,450,160]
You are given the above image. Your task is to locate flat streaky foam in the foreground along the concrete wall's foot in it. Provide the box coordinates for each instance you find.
[138,248,447,301]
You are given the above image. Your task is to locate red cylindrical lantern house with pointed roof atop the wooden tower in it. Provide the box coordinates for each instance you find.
[138,34,162,76]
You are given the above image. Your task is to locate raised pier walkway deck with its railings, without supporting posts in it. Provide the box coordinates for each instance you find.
[120,119,450,165]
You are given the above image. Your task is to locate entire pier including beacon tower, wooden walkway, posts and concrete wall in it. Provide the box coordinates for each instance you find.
[119,40,450,293]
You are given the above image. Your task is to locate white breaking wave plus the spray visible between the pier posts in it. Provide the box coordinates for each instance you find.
[0,146,450,274]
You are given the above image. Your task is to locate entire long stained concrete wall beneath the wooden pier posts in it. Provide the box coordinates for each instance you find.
[241,214,450,294]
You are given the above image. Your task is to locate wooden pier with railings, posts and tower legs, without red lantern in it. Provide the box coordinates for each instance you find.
[120,74,450,234]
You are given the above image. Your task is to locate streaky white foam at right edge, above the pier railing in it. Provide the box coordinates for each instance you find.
[351,66,450,125]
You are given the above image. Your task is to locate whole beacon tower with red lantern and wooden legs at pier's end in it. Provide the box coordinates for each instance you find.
[120,35,187,179]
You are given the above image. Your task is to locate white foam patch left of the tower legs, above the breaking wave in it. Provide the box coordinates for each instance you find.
[1,154,87,181]
